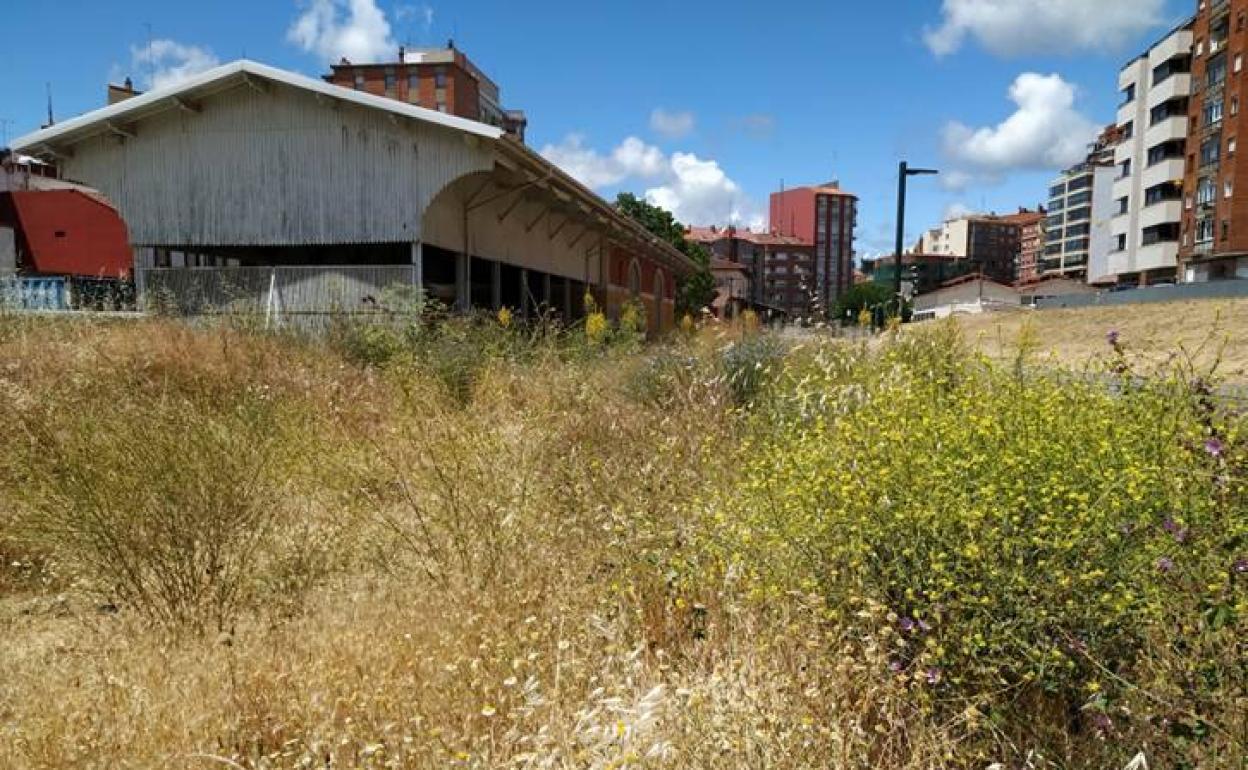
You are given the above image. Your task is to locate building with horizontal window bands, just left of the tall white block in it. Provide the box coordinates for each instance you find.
[1041,125,1132,281]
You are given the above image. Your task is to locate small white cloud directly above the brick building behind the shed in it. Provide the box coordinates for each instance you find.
[286,0,394,62]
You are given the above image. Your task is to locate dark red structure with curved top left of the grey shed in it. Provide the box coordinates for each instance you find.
[0,190,134,280]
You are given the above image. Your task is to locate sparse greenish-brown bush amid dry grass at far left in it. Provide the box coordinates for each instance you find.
[5,394,280,629]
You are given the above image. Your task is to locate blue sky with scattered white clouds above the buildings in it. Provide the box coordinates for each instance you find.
[0,0,1196,256]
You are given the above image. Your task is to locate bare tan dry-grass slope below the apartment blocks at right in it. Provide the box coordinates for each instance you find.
[943,300,1248,382]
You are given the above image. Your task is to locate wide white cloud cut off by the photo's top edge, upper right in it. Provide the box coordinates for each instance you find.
[924,0,1164,56]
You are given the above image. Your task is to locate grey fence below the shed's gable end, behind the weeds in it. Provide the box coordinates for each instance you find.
[136,265,417,326]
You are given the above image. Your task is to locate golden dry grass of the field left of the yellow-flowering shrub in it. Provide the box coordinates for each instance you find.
[0,317,1243,770]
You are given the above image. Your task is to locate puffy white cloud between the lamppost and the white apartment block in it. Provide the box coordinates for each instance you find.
[945,72,1098,188]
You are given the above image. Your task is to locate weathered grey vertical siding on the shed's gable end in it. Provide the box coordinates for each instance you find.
[65,84,494,246]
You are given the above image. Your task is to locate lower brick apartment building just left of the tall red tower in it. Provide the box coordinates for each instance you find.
[685,226,813,318]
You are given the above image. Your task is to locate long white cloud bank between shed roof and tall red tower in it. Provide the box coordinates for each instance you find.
[542,134,765,228]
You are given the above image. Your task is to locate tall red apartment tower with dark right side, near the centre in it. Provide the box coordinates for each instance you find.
[771,181,857,307]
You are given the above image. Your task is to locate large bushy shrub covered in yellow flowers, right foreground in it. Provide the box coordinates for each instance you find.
[719,327,1248,763]
